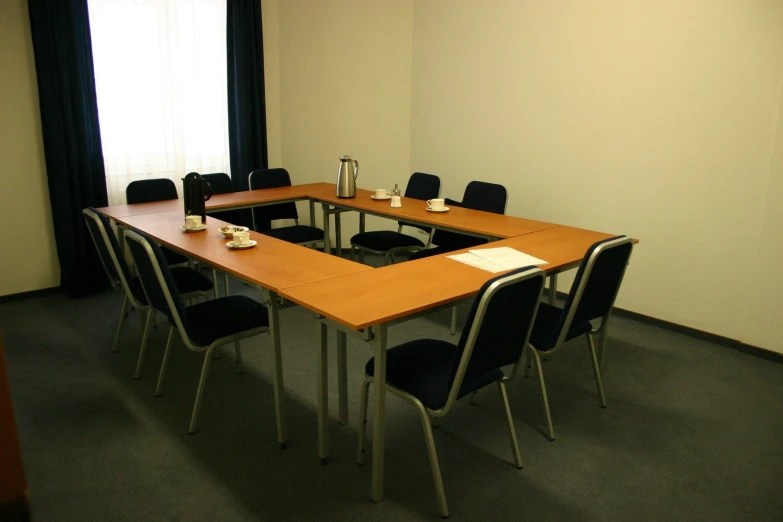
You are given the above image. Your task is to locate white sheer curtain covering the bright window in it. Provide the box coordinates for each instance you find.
[88,0,229,205]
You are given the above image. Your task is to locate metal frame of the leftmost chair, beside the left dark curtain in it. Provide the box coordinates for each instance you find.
[82,208,212,379]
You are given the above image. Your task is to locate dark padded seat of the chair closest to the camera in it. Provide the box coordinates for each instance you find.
[364,339,503,410]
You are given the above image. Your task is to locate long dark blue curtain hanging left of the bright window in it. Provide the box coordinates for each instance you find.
[27,0,108,297]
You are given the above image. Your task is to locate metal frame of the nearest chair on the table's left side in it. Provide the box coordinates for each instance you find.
[125,230,283,434]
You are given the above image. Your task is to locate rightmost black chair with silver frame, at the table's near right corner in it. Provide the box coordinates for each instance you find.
[530,236,633,440]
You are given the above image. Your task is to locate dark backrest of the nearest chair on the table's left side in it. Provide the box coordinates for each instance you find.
[125,229,188,334]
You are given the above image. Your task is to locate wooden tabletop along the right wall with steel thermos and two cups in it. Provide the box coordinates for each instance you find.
[308,183,558,238]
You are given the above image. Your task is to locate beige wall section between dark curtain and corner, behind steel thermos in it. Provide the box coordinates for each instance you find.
[274,0,413,235]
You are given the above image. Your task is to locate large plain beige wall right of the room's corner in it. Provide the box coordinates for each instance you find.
[411,0,783,351]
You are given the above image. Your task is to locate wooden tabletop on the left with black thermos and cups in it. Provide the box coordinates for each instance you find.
[117,211,372,293]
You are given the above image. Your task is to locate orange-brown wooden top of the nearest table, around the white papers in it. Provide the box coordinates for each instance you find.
[281,223,613,330]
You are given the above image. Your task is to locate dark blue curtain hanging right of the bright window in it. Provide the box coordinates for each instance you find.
[226,0,269,196]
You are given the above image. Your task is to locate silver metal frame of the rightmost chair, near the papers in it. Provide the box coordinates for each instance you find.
[525,236,633,440]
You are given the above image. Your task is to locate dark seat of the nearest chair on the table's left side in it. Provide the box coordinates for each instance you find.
[184,295,269,346]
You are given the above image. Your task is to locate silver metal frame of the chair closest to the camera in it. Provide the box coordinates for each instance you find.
[356,268,546,518]
